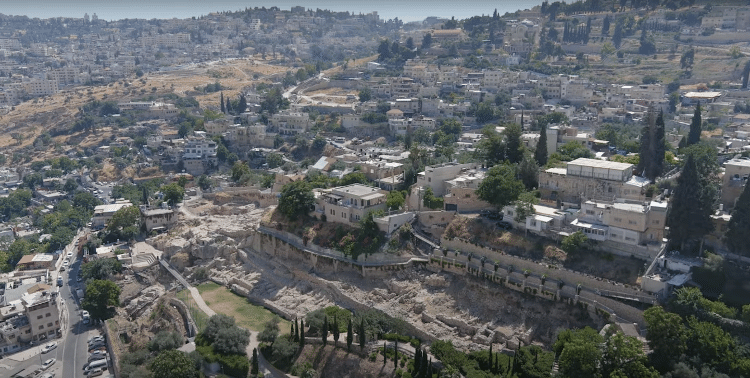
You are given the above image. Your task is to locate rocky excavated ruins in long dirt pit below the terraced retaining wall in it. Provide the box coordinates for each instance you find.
[154,200,603,350]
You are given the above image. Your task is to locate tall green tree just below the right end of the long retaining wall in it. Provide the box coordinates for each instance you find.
[643,306,687,372]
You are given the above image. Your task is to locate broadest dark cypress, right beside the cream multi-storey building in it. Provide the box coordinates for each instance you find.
[667,155,713,251]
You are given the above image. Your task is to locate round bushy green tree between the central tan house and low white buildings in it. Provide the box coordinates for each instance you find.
[477,164,524,209]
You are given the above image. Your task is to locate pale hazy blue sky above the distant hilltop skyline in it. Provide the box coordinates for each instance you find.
[0,0,542,22]
